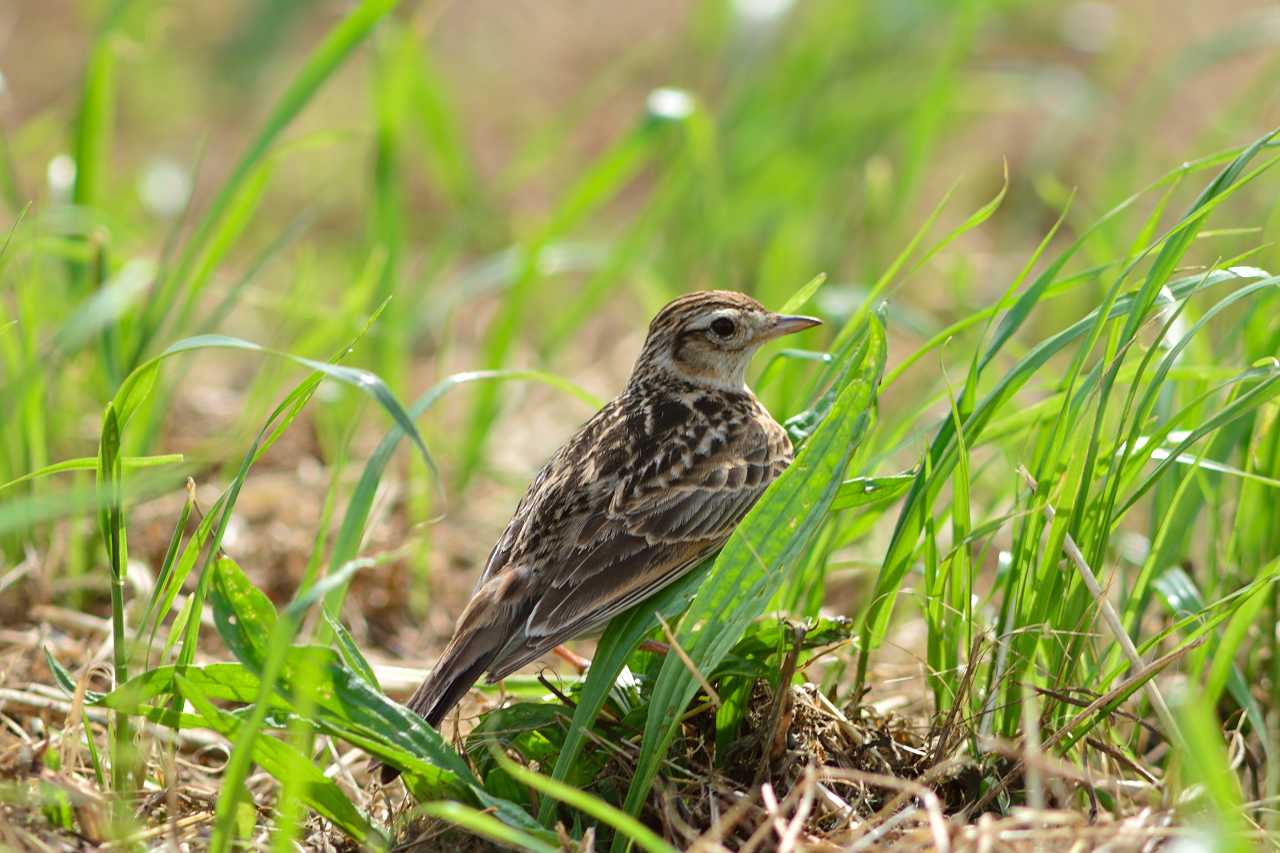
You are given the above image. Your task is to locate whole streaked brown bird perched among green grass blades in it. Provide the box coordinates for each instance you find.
[381,291,820,783]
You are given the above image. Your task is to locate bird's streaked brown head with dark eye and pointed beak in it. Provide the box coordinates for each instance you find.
[632,291,822,391]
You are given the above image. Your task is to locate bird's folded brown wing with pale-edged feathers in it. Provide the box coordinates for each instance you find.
[489,412,790,679]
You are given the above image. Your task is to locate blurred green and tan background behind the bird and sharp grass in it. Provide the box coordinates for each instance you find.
[0,0,1280,845]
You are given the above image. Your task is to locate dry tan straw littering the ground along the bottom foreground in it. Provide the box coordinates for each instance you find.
[0,578,1228,853]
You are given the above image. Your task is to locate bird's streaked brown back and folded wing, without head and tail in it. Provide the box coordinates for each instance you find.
[476,373,791,680]
